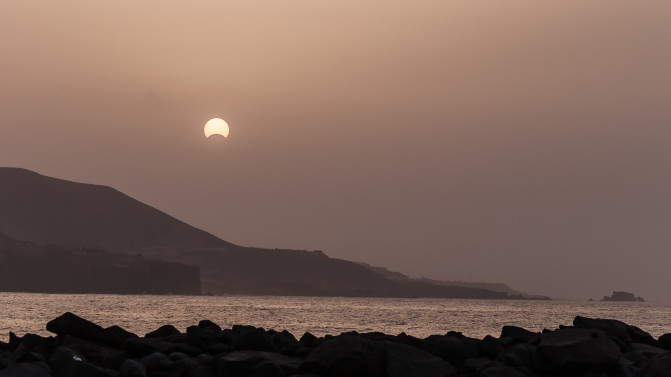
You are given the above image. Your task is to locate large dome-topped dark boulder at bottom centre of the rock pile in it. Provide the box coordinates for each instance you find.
[300,335,385,377]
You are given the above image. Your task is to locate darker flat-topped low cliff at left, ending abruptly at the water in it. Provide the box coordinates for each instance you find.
[0,234,200,294]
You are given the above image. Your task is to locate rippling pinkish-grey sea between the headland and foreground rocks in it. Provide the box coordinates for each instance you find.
[0,293,671,341]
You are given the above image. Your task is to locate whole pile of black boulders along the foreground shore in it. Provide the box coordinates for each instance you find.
[0,313,671,377]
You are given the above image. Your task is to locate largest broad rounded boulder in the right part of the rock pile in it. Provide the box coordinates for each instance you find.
[538,328,620,371]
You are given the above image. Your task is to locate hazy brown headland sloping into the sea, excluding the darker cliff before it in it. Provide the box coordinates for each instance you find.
[0,168,540,299]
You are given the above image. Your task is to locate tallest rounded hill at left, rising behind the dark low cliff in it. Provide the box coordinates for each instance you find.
[0,168,231,251]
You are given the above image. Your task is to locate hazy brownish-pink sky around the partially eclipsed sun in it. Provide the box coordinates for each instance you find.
[0,0,671,299]
